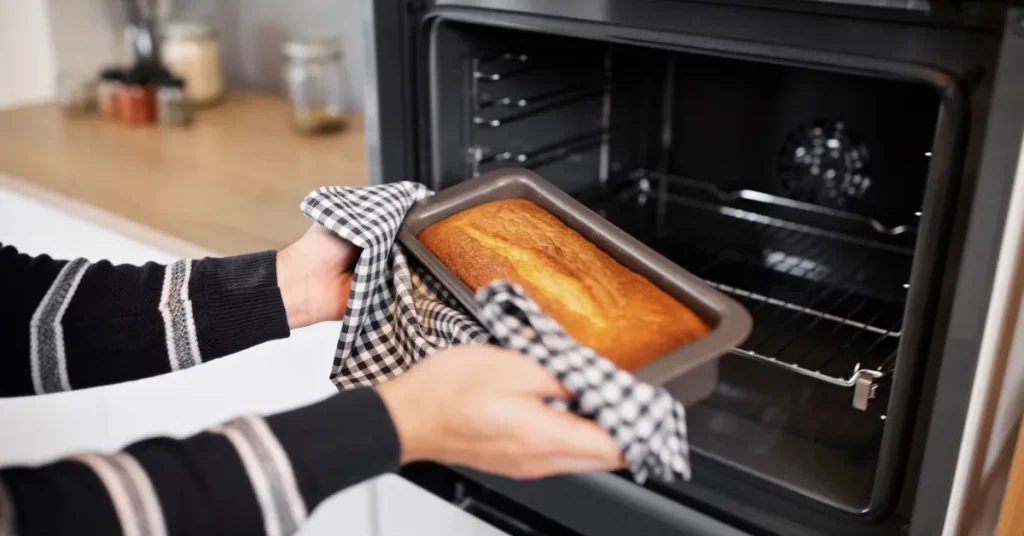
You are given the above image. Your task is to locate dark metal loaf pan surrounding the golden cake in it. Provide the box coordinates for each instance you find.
[398,168,753,404]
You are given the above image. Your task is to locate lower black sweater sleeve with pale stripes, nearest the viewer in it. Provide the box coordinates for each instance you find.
[0,387,400,536]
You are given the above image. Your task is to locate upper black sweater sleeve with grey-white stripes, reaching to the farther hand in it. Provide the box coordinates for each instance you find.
[0,246,289,397]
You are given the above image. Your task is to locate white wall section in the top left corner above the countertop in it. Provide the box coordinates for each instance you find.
[0,0,56,109]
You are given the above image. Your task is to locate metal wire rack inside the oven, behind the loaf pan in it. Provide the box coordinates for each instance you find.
[584,170,914,410]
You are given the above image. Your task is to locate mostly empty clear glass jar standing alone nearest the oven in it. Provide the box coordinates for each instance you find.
[282,37,345,134]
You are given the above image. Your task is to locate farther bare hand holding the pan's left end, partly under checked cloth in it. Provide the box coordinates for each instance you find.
[278,223,359,329]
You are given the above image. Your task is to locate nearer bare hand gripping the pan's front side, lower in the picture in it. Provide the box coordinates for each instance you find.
[377,345,624,479]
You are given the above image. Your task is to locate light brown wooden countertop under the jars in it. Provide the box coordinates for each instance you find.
[0,91,367,255]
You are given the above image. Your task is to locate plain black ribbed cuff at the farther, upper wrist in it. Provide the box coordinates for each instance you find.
[189,251,290,359]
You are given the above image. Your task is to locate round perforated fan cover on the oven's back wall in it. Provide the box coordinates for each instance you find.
[776,121,871,208]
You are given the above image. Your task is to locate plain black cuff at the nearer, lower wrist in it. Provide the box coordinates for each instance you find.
[266,387,400,510]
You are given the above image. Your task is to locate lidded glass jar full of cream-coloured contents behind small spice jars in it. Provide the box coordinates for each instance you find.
[160,18,224,106]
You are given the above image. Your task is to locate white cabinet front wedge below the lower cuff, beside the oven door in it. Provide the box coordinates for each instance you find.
[375,475,506,536]
